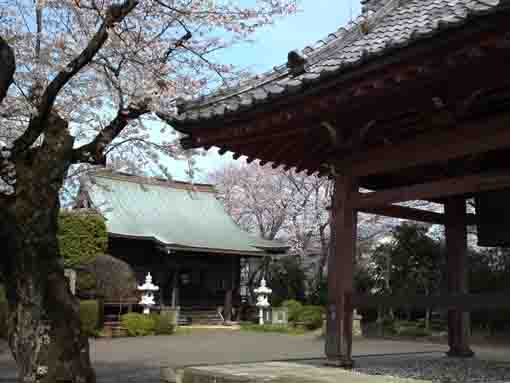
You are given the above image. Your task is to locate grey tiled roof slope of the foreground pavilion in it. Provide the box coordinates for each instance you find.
[170,0,510,129]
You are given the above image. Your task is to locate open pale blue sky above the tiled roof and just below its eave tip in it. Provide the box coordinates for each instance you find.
[169,0,360,181]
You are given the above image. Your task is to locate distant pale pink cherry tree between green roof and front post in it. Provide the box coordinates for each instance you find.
[209,162,398,298]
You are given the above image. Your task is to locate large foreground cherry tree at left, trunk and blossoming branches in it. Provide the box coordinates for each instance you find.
[0,0,296,383]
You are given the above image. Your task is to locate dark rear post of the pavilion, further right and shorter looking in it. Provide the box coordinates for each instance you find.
[445,197,474,357]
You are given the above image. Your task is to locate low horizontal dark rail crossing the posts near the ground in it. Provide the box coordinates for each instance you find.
[352,292,510,311]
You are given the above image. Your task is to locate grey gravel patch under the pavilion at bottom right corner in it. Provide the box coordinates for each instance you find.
[355,355,510,383]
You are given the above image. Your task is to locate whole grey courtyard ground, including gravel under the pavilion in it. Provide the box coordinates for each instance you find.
[0,330,510,383]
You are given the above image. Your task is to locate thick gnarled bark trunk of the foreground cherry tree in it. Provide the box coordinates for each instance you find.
[0,116,95,383]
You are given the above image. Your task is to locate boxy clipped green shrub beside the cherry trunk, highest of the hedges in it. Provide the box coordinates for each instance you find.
[57,212,108,267]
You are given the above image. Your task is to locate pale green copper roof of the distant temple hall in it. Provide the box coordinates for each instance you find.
[88,174,288,255]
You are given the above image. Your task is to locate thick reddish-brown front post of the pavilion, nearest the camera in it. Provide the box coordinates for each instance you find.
[326,176,358,368]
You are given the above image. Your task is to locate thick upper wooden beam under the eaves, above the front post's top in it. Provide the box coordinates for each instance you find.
[338,113,510,177]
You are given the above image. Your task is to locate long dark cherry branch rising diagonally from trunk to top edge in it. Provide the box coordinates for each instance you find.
[14,0,139,153]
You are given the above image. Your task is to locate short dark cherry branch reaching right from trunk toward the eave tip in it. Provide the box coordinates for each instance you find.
[72,102,150,165]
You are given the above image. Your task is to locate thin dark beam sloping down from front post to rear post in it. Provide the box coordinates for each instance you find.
[358,205,477,226]
